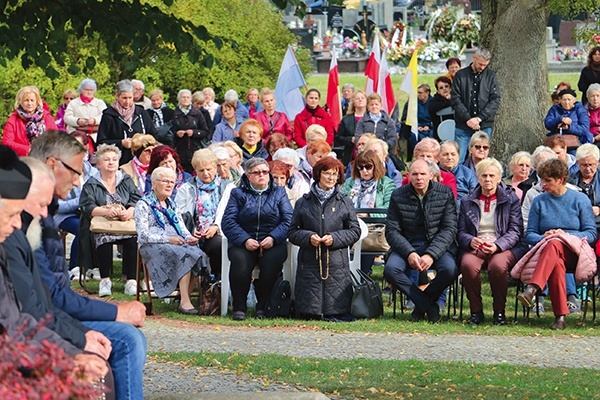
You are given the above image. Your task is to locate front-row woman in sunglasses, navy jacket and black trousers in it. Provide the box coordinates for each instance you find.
[222,158,293,321]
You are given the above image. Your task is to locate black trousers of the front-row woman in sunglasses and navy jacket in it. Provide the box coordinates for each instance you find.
[228,243,287,312]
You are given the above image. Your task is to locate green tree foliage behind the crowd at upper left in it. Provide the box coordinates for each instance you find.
[0,0,311,123]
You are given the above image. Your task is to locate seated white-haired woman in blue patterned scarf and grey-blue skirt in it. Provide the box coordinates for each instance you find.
[134,167,205,315]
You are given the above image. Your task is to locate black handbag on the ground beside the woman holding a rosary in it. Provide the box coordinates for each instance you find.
[350,270,383,318]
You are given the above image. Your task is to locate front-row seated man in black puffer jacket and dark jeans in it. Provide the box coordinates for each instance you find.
[384,159,458,323]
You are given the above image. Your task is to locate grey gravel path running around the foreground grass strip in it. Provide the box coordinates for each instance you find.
[143,320,600,394]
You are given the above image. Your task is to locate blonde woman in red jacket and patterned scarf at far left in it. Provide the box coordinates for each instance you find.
[2,86,57,156]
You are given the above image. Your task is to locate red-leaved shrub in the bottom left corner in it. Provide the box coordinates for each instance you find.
[0,326,102,399]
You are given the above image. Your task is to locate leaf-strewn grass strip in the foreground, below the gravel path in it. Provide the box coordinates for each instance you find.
[154,353,600,399]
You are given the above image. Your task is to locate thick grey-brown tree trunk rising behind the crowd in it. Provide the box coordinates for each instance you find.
[481,0,550,162]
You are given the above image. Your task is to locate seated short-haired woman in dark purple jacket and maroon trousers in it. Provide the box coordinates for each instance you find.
[456,158,528,325]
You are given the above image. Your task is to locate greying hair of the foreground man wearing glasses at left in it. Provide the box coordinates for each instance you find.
[29,130,86,162]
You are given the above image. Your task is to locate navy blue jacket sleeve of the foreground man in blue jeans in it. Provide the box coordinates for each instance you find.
[34,200,117,321]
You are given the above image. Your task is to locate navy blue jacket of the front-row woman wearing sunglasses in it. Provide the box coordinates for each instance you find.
[221,174,294,247]
